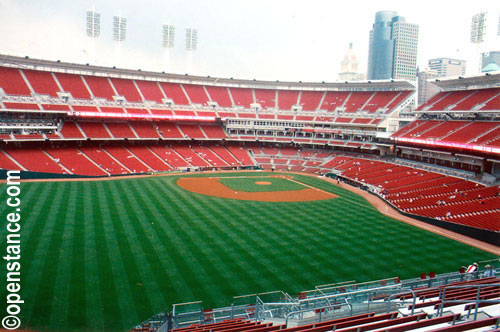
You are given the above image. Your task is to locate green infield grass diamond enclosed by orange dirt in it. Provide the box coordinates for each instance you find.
[219,176,307,192]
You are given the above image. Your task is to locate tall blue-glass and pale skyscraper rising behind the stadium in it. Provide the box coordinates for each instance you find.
[367,11,418,80]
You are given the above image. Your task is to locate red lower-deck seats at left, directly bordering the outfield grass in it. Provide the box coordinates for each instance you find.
[0,144,254,176]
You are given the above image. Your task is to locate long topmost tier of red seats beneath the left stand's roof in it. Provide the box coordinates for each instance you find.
[0,67,411,113]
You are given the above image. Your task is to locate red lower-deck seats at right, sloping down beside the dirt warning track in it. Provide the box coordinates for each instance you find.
[332,158,500,232]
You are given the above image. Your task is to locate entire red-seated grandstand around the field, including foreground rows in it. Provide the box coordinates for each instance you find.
[0,56,500,332]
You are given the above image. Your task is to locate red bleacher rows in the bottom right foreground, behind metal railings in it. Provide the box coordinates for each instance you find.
[131,273,500,332]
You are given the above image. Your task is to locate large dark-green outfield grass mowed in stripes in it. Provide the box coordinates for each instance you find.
[0,173,495,331]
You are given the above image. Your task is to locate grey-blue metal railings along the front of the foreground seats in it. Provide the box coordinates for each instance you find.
[141,271,500,331]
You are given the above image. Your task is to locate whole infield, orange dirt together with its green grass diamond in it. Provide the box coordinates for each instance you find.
[177,176,337,202]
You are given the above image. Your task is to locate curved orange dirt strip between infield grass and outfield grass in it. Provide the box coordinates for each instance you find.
[177,177,337,202]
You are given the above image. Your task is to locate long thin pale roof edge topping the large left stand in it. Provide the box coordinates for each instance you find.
[0,54,415,91]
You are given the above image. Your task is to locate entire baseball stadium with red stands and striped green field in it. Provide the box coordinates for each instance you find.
[0,55,500,332]
